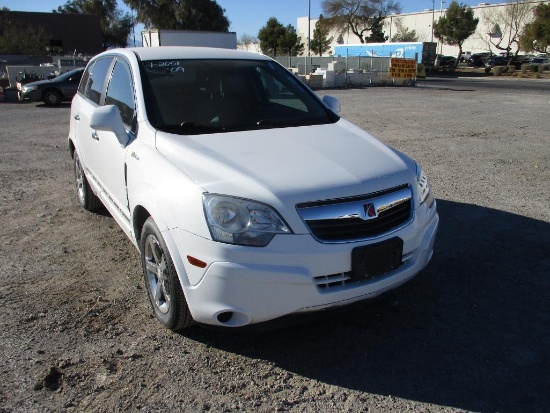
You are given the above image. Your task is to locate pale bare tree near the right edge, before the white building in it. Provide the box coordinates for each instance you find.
[481,1,535,56]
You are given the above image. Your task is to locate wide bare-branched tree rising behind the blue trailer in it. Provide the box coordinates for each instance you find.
[321,0,401,43]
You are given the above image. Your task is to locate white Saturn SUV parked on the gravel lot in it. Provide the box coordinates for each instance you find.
[69,47,439,330]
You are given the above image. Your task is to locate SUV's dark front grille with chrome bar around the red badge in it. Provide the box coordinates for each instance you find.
[298,187,412,242]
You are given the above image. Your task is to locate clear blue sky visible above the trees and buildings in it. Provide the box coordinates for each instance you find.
[0,0,492,38]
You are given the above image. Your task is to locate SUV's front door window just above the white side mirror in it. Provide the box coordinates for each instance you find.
[105,60,134,126]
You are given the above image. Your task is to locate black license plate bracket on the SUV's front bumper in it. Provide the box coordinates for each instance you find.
[351,237,403,281]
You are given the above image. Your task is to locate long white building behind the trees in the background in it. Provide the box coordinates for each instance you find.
[296,0,548,55]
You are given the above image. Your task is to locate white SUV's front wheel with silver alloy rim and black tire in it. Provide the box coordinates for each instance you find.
[140,218,195,331]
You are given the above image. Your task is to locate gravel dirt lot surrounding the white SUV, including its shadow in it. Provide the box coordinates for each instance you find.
[0,81,550,412]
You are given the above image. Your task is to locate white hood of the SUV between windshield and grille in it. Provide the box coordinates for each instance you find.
[156,119,414,222]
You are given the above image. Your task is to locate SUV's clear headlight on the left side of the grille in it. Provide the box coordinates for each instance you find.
[203,194,291,247]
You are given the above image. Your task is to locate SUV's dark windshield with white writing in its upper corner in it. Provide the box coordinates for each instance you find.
[142,60,338,135]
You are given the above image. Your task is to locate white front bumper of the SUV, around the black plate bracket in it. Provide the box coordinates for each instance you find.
[165,202,439,327]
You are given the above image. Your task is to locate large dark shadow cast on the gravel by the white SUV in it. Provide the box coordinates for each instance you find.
[182,200,550,412]
